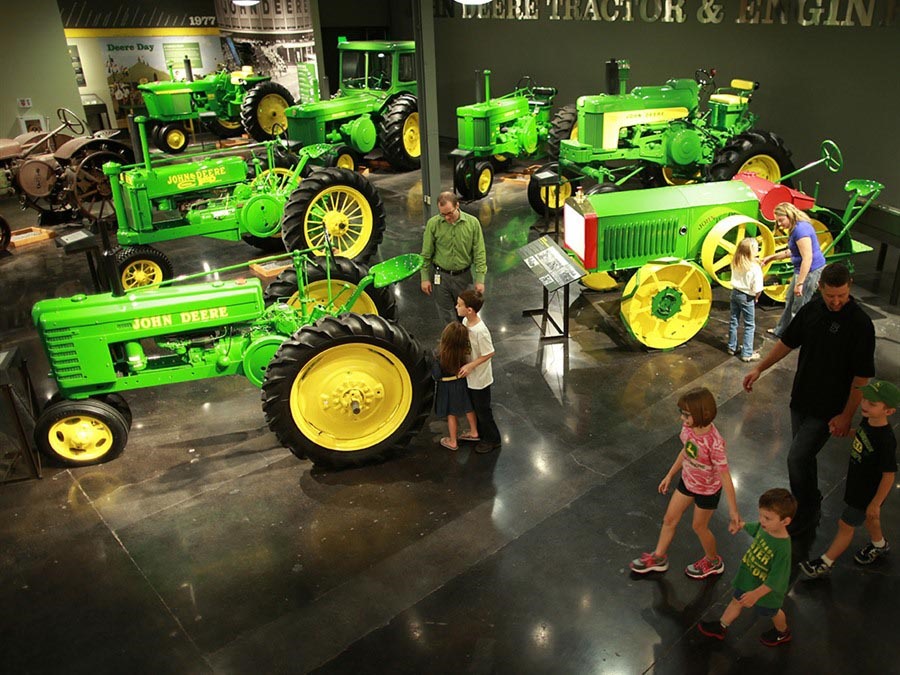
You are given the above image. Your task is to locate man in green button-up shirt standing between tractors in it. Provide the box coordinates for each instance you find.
[422,192,487,325]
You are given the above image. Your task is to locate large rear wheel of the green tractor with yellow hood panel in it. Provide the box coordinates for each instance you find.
[709,129,794,185]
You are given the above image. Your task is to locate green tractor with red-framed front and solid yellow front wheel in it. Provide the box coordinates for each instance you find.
[564,141,884,349]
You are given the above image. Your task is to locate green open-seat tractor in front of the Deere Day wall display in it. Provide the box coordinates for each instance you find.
[138,60,294,154]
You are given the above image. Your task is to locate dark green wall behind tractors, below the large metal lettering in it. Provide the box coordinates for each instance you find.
[435,5,900,205]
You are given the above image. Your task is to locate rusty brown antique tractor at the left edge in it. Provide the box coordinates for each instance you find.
[0,108,134,225]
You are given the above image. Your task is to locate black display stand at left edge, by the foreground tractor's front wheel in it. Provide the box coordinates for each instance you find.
[0,347,41,483]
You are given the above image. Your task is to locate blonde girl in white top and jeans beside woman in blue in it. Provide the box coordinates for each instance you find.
[728,237,763,362]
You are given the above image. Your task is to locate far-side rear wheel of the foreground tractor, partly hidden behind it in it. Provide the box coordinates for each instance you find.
[263,258,398,321]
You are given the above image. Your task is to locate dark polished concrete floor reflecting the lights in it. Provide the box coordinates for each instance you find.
[0,151,900,674]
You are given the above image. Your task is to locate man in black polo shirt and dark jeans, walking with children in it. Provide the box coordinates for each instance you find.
[744,263,875,534]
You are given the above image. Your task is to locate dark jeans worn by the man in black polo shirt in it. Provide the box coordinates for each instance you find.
[788,409,831,529]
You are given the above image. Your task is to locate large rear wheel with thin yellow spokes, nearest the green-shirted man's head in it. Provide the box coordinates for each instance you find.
[281,167,385,262]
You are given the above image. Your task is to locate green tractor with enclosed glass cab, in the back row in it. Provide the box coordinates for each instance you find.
[268,41,421,171]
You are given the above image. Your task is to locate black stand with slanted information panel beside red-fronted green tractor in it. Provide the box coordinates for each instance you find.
[517,235,587,340]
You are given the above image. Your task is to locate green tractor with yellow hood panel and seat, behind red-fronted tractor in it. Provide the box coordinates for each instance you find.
[528,60,794,214]
